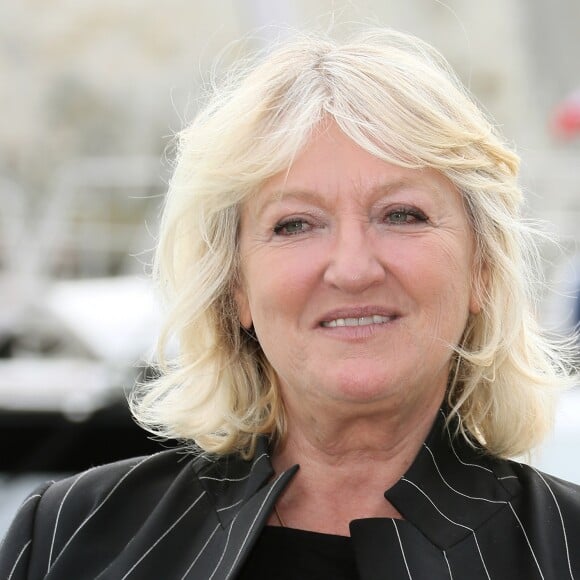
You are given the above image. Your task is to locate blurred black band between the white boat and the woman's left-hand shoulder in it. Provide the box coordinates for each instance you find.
[0,401,174,475]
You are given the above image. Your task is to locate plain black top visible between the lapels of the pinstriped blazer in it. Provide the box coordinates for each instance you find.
[238,526,359,580]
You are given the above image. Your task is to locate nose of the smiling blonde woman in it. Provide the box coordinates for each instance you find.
[324,223,386,294]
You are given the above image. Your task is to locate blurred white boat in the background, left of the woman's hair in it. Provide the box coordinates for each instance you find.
[0,276,159,420]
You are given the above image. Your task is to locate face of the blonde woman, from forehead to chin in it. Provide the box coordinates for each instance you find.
[236,124,478,422]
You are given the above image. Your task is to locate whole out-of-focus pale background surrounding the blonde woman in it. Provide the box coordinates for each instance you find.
[0,0,580,535]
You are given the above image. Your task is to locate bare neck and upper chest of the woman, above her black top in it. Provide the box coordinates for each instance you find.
[273,399,441,535]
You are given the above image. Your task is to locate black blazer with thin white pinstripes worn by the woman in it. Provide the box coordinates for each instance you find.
[0,416,580,580]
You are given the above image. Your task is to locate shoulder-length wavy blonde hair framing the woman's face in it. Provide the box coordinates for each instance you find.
[131,29,569,456]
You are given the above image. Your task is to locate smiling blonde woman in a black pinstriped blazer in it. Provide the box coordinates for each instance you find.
[0,30,580,580]
